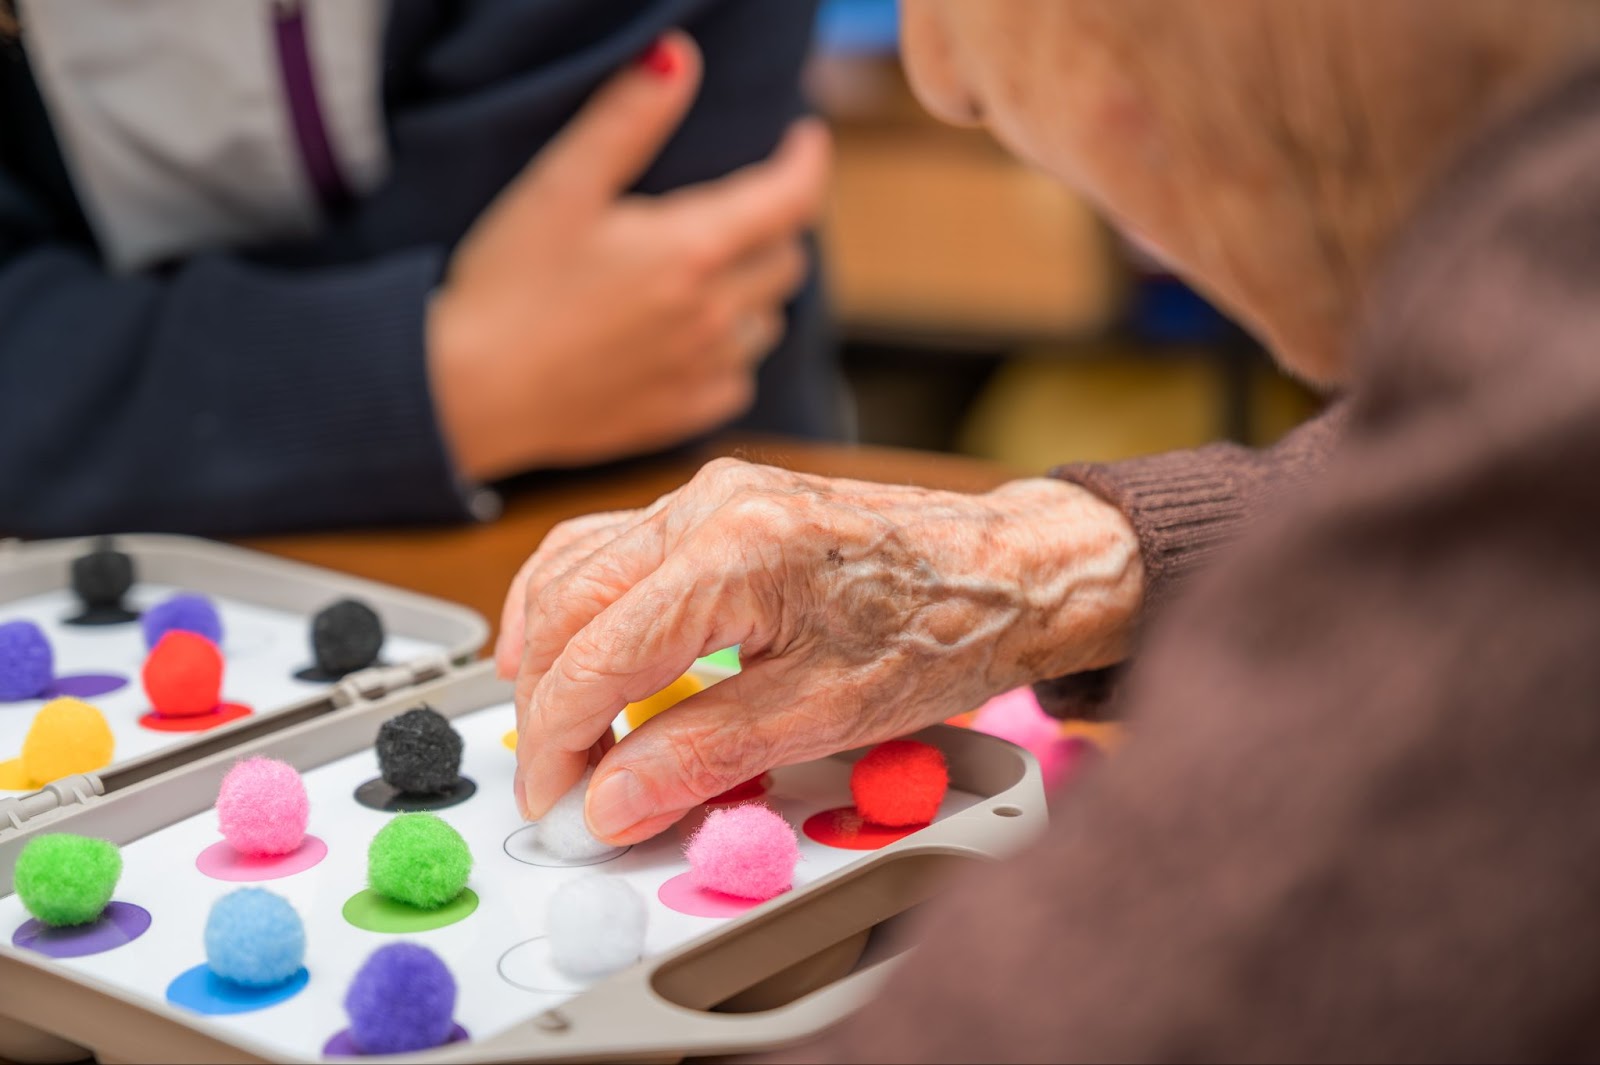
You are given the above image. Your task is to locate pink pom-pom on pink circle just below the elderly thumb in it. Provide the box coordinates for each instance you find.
[683,803,800,900]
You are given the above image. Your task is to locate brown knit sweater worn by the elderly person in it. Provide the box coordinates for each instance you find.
[802,64,1600,1062]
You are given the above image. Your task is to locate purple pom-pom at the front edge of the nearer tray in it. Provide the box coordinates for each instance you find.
[344,943,456,1054]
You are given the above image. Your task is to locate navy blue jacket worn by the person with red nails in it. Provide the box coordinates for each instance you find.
[0,0,834,536]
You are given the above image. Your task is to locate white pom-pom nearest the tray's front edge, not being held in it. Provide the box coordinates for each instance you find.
[546,873,648,979]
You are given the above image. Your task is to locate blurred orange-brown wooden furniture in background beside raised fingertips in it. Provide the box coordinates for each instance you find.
[811,58,1123,344]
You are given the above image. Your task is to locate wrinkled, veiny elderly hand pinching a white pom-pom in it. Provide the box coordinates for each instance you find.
[496,461,1142,844]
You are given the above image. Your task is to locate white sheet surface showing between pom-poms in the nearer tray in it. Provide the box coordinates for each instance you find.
[0,697,982,1059]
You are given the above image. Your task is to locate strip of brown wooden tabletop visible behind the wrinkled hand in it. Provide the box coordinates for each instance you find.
[245,437,1014,641]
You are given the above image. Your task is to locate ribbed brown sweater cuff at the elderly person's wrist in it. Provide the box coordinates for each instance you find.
[1051,445,1250,612]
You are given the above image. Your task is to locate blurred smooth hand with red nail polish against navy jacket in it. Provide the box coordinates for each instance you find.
[427,32,829,480]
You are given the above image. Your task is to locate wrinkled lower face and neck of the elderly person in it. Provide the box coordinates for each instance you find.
[902,0,1600,384]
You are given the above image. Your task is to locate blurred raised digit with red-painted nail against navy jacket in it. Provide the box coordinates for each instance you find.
[517,30,701,221]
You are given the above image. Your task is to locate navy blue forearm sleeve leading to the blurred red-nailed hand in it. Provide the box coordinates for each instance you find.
[0,173,466,536]
